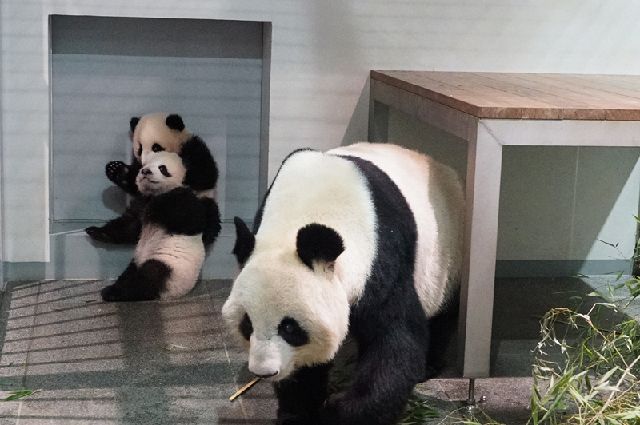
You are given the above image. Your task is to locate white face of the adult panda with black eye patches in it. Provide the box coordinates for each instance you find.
[222,220,349,380]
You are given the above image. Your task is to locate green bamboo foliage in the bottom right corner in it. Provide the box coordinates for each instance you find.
[529,302,640,425]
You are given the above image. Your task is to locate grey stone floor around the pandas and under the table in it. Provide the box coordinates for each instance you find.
[0,279,624,425]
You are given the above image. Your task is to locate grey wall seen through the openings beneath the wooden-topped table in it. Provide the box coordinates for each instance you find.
[389,109,640,276]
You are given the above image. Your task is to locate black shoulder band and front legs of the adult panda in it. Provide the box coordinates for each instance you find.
[276,157,429,425]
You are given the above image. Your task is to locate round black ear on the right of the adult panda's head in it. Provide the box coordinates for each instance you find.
[296,223,344,270]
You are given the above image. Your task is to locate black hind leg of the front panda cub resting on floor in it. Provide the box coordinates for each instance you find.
[101,260,171,302]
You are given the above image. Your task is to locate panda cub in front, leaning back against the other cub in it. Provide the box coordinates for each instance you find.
[102,152,220,301]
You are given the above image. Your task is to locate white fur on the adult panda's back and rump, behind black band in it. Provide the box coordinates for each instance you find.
[328,143,464,316]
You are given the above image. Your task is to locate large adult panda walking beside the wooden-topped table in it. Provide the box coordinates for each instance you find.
[222,143,464,425]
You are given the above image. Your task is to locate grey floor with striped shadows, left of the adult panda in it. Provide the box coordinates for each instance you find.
[0,281,275,424]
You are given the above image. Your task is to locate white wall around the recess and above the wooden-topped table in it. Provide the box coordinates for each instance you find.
[0,0,640,261]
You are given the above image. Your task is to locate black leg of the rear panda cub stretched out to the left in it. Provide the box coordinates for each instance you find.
[85,197,147,244]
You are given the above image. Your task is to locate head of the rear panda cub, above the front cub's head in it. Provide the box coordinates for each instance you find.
[130,113,191,163]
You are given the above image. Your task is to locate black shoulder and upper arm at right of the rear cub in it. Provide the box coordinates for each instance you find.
[180,136,218,191]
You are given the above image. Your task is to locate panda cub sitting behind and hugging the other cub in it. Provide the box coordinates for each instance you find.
[86,113,218,245]
